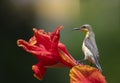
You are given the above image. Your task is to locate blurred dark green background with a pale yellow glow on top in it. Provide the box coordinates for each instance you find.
[0,0,120,83]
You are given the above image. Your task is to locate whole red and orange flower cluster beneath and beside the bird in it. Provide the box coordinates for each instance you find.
[17,26,107,83]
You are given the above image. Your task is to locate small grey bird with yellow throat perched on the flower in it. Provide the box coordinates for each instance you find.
[73,24,102,72]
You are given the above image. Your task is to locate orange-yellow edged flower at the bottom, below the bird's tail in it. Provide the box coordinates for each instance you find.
[69,65,107,83]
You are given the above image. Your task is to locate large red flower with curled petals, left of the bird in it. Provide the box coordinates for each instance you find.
[17,26,76,80]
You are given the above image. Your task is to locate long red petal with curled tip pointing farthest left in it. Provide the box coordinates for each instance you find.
[17,39,53,60]
